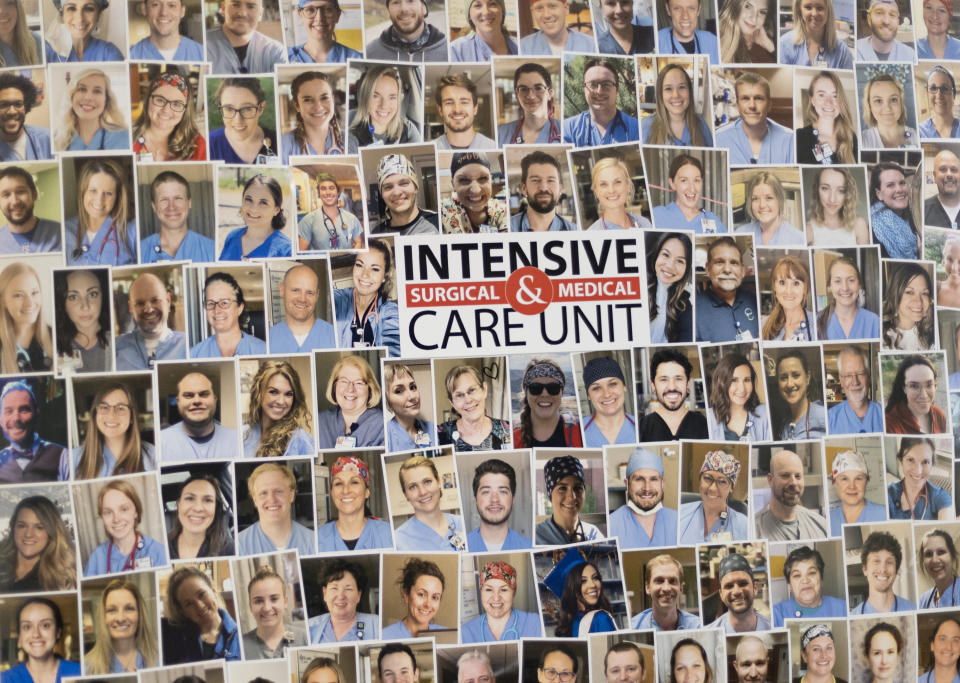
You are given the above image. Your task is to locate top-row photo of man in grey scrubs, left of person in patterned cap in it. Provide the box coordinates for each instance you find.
[207,0,287,74]
